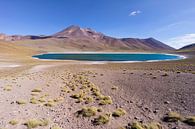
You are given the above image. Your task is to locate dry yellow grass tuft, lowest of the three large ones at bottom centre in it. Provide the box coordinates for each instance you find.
[93,113,111,125]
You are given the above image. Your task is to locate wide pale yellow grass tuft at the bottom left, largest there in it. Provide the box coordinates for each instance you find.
[24,119,49,129]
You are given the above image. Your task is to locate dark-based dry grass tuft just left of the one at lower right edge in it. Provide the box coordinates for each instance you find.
[164,112,183,122]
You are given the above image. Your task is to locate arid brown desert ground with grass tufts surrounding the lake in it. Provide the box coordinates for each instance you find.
[0,43,195,129]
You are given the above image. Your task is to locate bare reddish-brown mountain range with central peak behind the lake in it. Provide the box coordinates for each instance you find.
[0,25,174,51]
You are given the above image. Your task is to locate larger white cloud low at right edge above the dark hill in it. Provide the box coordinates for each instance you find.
[166,33,195,48]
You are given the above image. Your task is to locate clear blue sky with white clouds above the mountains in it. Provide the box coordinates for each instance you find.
[0,0,195,48]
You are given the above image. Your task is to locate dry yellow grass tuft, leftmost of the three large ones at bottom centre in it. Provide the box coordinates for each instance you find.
[77,106,97,117]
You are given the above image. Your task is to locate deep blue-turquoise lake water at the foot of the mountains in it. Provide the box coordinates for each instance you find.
[33,53,183,62]
